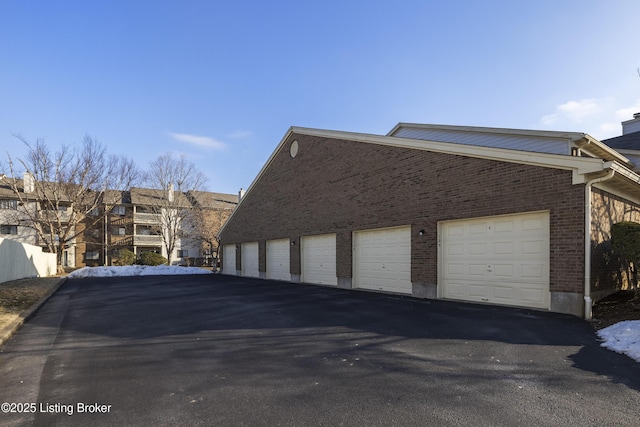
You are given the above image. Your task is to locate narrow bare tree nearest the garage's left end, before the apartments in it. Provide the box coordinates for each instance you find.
[145,153,206,265]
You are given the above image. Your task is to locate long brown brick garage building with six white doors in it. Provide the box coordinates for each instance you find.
[220,124,640,317]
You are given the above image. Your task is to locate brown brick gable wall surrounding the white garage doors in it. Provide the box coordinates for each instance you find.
[221,134,584,293]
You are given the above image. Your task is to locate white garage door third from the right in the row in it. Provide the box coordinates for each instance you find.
[300,234,338,285]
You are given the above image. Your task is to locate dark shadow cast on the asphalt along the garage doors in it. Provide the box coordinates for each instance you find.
[33,275,640,390]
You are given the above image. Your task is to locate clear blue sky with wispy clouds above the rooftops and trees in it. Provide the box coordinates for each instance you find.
[0,0,640,193]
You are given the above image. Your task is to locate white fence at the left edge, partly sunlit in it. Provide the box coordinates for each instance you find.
[0,238,57,283]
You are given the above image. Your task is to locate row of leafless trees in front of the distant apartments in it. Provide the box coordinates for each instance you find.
[0,136,213,269]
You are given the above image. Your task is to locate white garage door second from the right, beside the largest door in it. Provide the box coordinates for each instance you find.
[353,227,411,294]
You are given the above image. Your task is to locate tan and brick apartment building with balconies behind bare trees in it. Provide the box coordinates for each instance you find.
[0,175,239,268]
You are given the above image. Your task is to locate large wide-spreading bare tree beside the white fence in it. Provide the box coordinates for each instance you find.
[5,136,139,270]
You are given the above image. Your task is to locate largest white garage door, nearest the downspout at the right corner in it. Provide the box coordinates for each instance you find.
[440,212,550,309]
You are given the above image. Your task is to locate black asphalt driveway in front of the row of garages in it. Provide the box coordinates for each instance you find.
[0,275,640,426]
